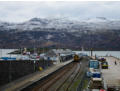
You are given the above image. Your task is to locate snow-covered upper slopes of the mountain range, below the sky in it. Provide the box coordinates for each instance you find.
[0,17,120,32]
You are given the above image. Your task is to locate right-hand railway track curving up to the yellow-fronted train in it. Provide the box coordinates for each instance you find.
[56,58,87,91]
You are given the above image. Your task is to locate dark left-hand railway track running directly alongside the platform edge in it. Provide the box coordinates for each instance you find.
[21,63,73,91]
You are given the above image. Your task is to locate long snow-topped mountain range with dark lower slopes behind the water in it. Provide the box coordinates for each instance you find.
[0,17,120,50]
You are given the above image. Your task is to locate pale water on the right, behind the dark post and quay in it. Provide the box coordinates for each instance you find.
[75,51,120,58]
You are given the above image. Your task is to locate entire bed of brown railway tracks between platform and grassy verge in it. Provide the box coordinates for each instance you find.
[22,58,87,91]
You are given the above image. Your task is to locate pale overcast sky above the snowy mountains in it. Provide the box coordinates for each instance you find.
[0,1,120,22]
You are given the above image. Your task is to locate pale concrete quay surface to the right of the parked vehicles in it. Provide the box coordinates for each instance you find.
[102,57,120,88]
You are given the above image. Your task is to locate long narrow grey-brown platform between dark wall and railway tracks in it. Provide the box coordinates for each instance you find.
[0,59,73,91]
